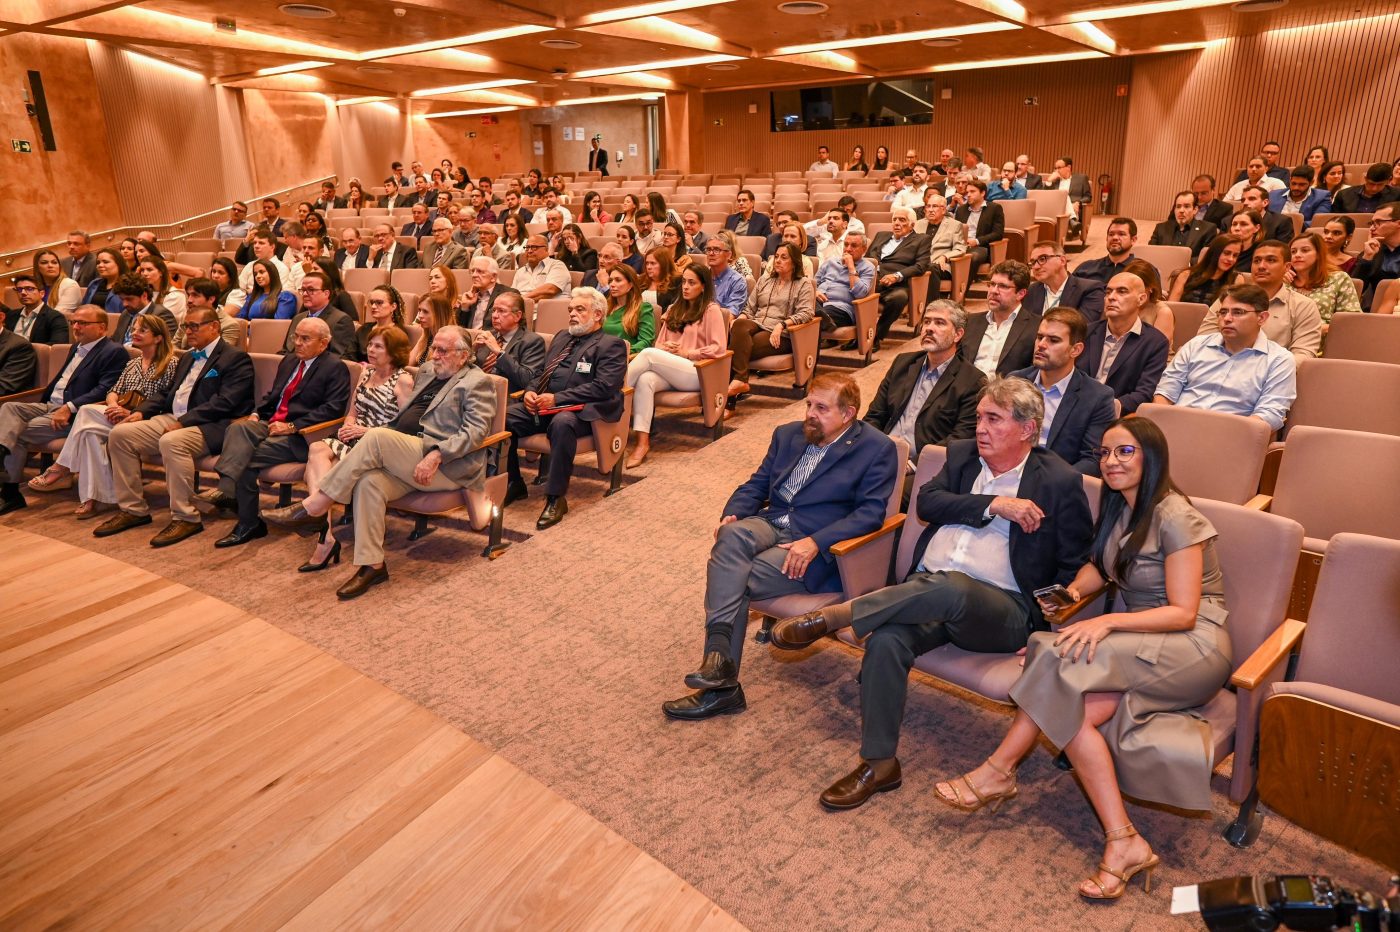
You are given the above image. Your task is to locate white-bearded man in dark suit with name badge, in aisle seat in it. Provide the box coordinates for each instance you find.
[505,282,627,530]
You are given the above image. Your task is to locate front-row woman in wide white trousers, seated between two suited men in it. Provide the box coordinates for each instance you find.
[29,313,176,519]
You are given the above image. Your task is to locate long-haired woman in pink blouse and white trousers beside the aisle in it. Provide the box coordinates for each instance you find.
[627,263,728,469]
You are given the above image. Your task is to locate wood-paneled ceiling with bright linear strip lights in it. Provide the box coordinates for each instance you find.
[0,0,1400,113]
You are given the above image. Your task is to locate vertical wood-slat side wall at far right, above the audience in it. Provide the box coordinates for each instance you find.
[1117,0,1400,217]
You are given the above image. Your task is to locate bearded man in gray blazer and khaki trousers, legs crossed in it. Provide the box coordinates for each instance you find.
[263,326,496,599]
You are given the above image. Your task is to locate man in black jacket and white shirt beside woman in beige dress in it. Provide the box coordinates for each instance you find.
[773,378,1093,810]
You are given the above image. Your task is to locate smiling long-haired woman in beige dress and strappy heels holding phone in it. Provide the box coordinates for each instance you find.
[934,417,1231,900]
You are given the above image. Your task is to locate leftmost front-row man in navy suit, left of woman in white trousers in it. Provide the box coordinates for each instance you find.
[0,304,127,515]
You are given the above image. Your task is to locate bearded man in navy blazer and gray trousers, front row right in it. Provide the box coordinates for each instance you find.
[661,372,903,721]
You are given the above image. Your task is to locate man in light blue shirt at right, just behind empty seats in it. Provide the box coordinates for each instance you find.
[1152,284,1298,431]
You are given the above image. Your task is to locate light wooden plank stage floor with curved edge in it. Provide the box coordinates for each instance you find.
[0,528,742,931]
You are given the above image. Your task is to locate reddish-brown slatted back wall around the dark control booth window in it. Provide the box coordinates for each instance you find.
[703,59,1131,188]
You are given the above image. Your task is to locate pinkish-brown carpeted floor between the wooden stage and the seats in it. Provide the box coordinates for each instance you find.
[7,282,1383,929]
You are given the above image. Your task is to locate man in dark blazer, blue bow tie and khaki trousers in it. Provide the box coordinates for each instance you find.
[92,308,253,547]
